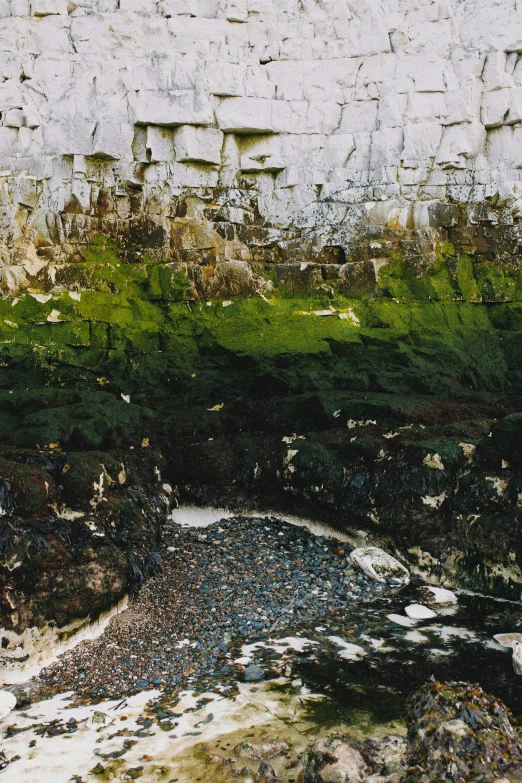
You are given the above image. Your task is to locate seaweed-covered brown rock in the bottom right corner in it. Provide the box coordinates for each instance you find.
[404,682,522,783]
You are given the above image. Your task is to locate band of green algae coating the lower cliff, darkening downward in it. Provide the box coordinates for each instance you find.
[0,236,522,595]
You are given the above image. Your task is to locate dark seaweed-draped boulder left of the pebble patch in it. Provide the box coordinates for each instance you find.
[0,390,172,657]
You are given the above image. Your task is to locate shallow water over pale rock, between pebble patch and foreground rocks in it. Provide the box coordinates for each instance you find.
[0,508,522,783]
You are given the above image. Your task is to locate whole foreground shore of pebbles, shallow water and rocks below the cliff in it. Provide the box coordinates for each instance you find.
[0,516,522,783]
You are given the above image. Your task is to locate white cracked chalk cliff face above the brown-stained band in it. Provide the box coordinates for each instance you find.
[0,0,522,263]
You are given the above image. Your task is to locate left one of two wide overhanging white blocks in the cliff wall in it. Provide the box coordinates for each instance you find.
[129,90,213,127]
